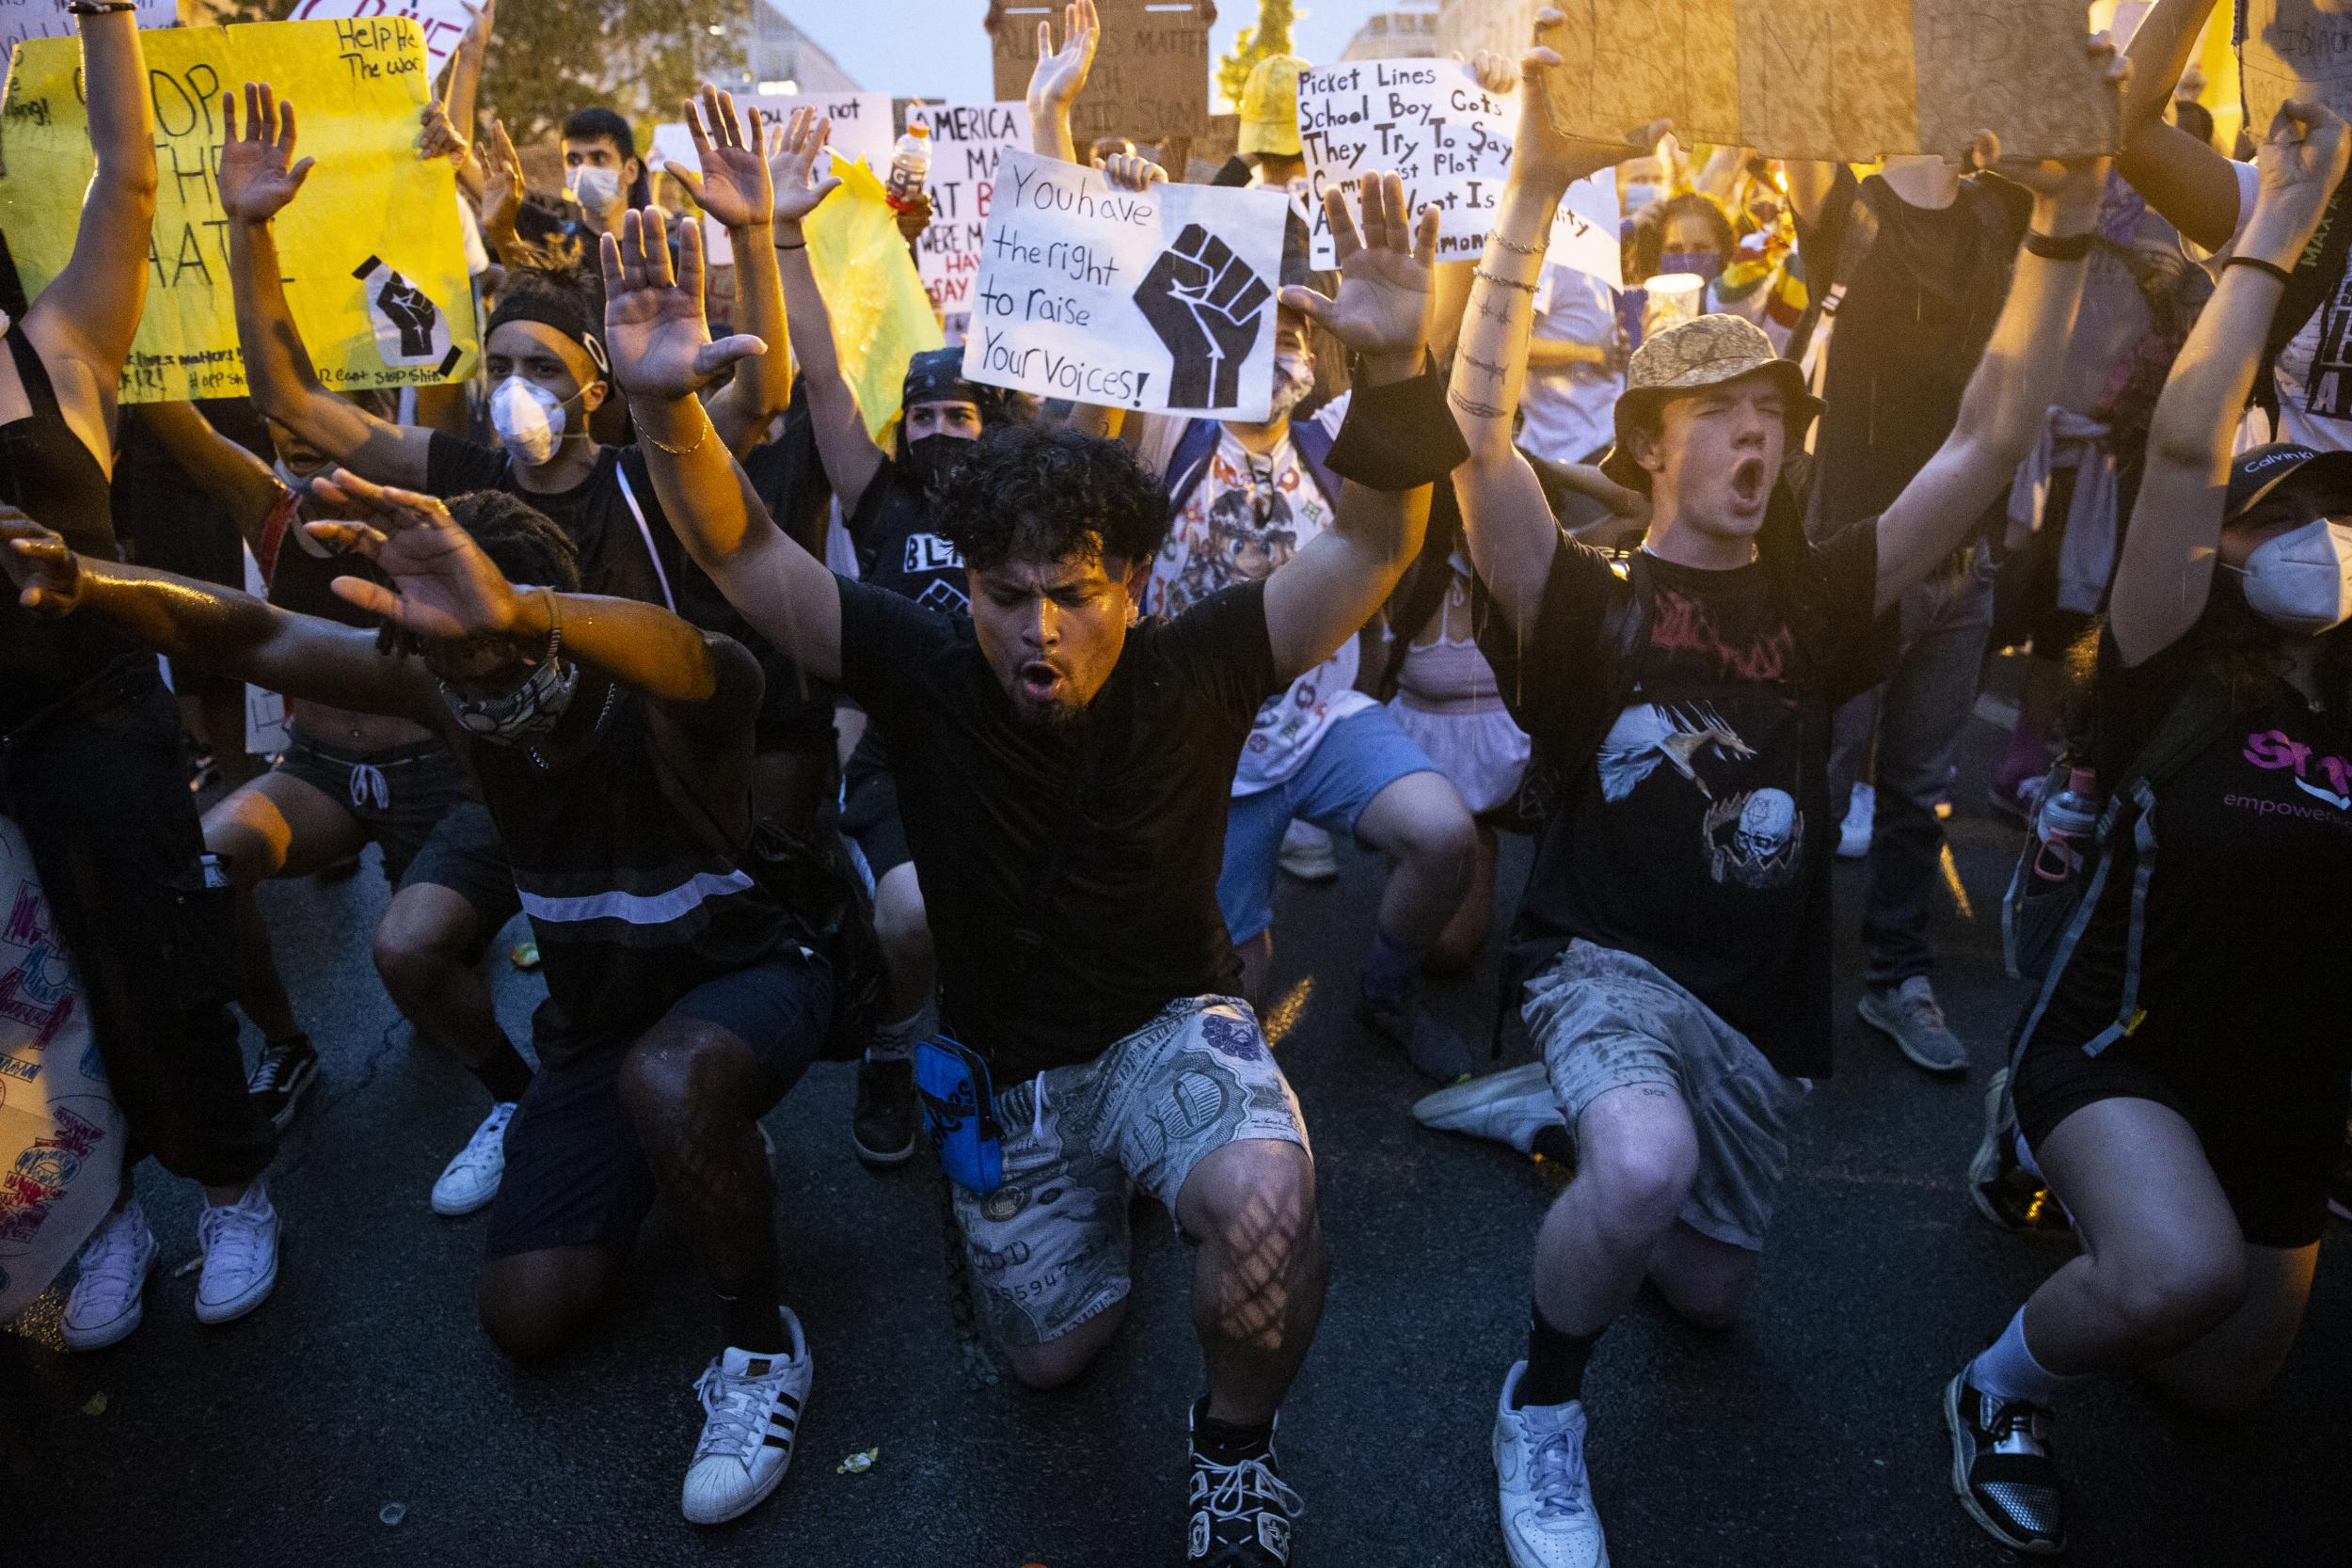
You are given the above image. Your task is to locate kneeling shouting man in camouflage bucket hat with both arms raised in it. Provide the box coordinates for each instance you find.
[1421,15,2122,1568]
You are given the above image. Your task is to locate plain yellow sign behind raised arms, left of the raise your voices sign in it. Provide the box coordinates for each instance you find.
[807,157,948,442]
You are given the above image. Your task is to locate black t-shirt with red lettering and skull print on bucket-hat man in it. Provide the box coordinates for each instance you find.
[1482,519,1884,1077]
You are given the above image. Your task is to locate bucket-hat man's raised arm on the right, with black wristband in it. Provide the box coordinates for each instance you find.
[1877,33,2131,611]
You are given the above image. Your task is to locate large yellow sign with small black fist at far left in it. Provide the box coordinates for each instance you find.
[0,16,478,402]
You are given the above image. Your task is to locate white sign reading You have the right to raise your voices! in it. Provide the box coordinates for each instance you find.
[964,148,1292,420]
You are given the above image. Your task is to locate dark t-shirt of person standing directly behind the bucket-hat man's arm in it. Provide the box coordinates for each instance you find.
[1800,166,2030,536]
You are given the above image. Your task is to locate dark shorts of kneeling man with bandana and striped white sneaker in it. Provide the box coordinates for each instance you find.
[487,947,833,1258]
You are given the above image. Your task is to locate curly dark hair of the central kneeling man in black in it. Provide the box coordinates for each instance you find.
[934,423,1169,571]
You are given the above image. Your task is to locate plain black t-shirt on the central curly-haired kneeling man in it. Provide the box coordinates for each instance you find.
[840,578,1282,1082]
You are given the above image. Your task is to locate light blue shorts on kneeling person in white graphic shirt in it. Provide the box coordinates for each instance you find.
[1216,707,1438,947]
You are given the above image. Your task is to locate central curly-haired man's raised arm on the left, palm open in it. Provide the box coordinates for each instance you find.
[600,207,842,679]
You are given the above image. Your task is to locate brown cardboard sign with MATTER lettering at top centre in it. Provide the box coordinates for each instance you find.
[988,0,1209,150]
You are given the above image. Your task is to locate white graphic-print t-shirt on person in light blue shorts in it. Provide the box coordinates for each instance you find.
[1143,430,1374,795]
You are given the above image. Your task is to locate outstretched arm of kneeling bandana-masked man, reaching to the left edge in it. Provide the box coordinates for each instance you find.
[0,508,442,724]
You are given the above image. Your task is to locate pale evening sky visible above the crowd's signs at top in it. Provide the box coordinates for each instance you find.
[781,0,1397,108]
